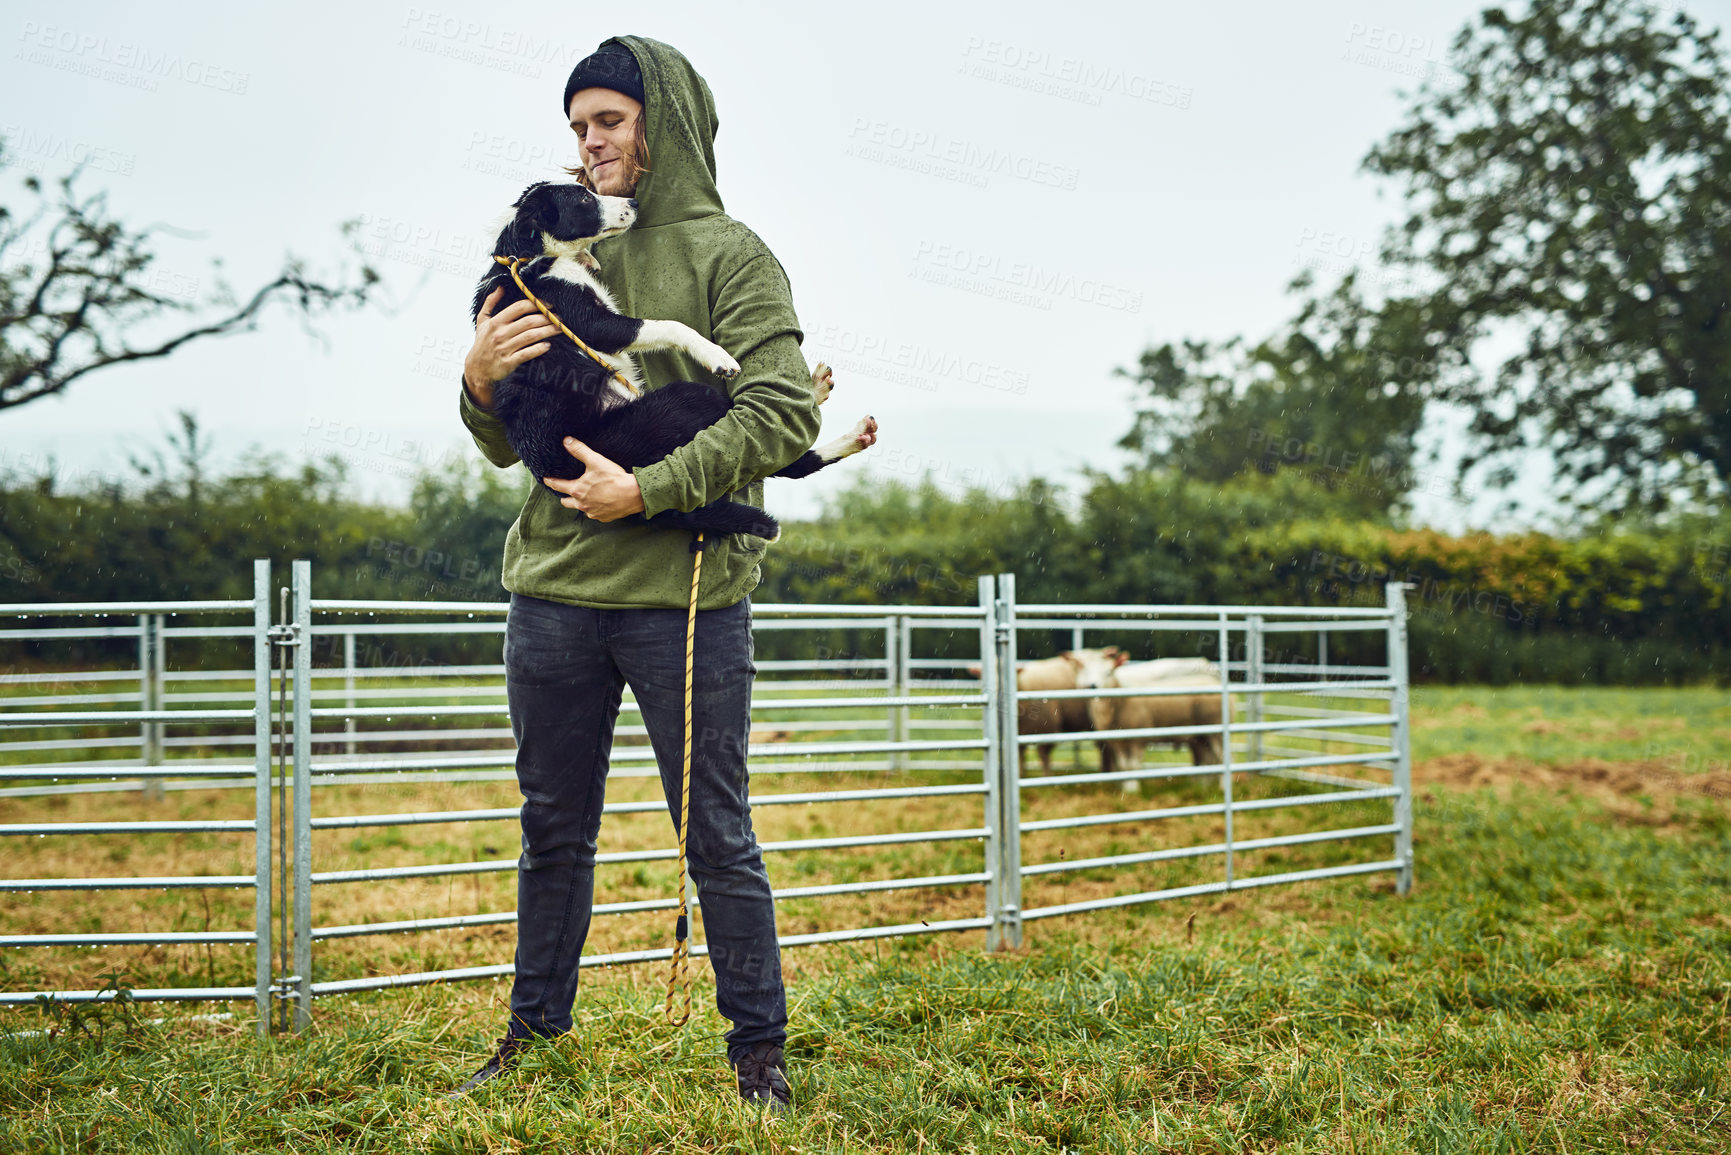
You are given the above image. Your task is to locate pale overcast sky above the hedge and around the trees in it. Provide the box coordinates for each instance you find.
[0,0,1731,528]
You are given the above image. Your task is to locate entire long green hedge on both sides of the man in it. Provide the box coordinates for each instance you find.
[0,462,1731,684]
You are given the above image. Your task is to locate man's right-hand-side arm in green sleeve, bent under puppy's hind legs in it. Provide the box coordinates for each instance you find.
[632,253,822,518]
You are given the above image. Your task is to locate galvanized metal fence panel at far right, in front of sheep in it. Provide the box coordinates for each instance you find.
[1004,584,1411,918]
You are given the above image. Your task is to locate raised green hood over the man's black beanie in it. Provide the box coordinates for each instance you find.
[602,36,722,232]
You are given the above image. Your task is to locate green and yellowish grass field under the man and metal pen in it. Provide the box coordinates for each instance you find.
[0,687,1731,1153]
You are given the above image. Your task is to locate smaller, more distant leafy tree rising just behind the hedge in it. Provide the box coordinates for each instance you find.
[1118,275,1430,516]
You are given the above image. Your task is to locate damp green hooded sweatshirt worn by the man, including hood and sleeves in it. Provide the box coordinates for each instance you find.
[459,36,822,610]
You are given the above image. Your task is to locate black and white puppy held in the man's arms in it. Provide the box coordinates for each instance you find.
[469,182,878,539]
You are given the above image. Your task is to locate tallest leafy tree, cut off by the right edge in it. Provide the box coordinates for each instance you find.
[1364,0,1731,513]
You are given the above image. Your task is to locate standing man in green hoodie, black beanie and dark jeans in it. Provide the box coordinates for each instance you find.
[452,36,820,1112]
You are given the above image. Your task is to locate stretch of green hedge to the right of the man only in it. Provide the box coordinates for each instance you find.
[760,474,1731,684]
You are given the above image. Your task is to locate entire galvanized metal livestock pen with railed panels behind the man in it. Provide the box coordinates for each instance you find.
[0,561,1412,1030]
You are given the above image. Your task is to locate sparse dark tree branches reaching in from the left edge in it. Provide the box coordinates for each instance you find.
[0,142,377,409]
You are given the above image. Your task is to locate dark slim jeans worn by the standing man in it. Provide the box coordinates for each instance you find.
[505,594,788,1058]
